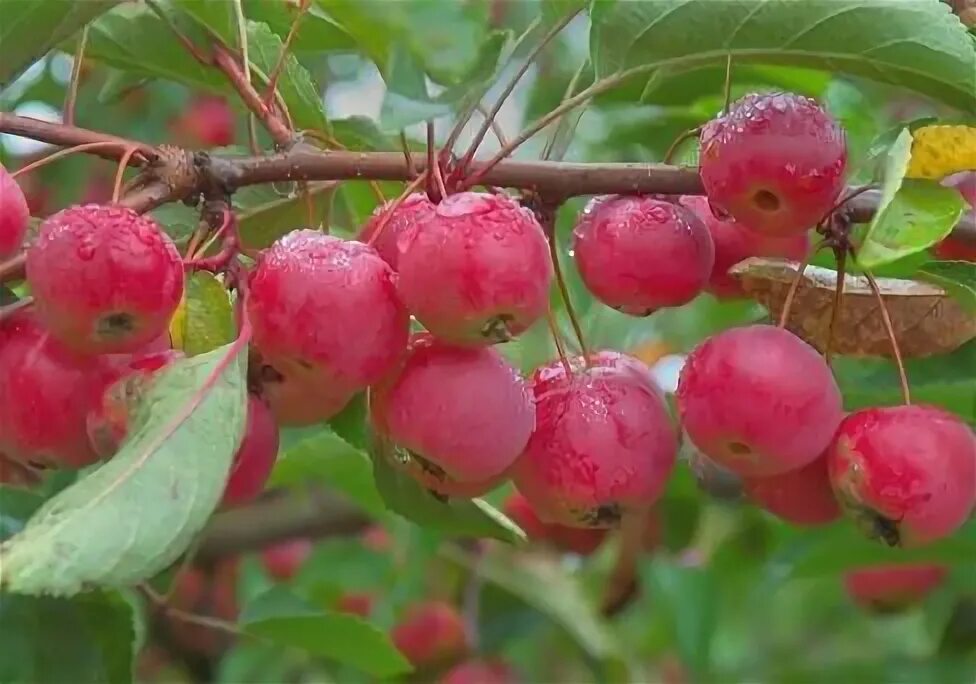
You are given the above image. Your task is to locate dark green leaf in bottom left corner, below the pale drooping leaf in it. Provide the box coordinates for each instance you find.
[0,592,135,684]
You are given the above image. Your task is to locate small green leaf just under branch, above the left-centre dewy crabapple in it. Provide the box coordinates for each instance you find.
[238,183,335,249]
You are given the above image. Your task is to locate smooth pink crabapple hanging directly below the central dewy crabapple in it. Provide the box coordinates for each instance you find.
[370,334,535,497]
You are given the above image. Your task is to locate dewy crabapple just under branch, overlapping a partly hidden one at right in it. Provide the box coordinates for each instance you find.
[573,195,715,316]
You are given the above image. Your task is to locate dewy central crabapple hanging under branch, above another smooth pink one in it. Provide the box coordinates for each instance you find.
[397,192,553,346]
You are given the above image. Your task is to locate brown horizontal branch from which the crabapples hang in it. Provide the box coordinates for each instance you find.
[0,114,976,244]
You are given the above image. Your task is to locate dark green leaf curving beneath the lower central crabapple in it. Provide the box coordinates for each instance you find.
[371,437,525,544]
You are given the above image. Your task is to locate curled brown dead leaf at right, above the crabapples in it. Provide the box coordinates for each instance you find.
[731,258,976,358]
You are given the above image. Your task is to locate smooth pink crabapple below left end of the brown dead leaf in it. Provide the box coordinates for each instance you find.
[676,325,843,477]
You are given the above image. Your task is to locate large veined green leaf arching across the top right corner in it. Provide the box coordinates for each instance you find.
[590,0,976,111]
